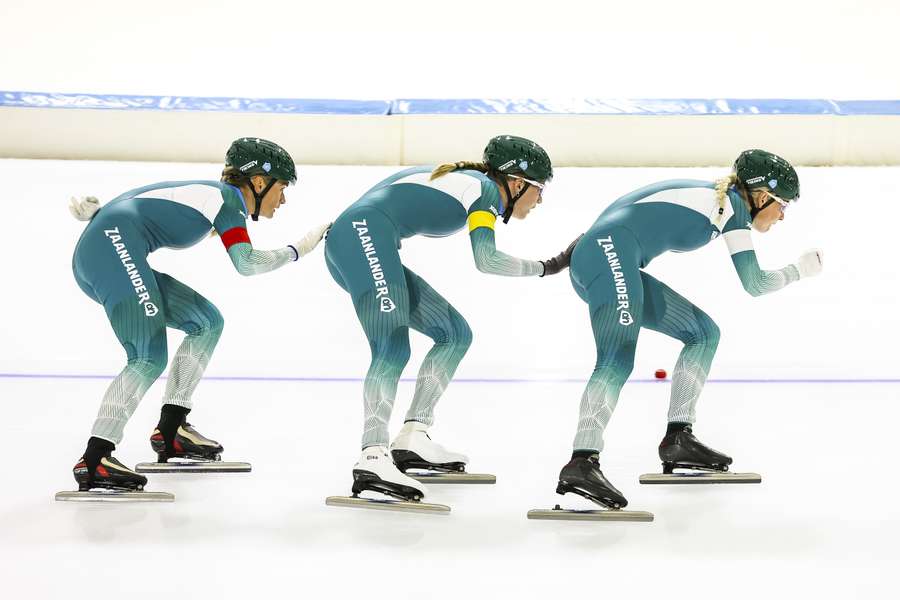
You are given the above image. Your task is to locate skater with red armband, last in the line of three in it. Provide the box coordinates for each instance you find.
[71,138,328,491]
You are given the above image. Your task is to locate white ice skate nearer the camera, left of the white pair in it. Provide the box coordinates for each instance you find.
[325,446,450,513]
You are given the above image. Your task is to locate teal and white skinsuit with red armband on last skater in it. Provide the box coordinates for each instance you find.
[72,181,296,444]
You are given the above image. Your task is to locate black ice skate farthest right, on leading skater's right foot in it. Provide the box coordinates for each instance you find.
[640,425,762,484]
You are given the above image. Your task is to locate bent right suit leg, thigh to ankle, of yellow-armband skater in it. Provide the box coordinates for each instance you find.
[404,267,472,426]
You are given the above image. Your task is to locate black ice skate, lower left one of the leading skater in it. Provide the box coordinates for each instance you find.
[528,454,653,521]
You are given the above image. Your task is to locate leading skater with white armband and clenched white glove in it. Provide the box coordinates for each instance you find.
[557,150,822,508]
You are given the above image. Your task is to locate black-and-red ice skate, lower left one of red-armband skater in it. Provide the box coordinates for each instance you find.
[56,456,175,502]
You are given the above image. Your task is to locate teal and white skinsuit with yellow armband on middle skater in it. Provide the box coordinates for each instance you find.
[325,167,543,448]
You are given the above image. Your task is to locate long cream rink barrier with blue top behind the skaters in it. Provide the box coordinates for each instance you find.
[0,92,900,167]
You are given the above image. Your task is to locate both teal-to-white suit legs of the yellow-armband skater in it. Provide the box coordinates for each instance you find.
[325,208,472,448]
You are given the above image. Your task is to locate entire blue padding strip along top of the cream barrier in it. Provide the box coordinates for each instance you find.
[0,91,900,116]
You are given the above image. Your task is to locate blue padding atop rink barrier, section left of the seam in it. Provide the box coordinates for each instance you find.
[0,91,391,115]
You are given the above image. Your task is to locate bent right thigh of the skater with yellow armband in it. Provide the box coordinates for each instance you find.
[403,267,472,343]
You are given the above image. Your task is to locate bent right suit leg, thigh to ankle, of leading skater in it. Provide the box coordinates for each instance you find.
[641,272,719,423]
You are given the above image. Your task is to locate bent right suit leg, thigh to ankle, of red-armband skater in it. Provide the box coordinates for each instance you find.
[154,271,225,409]
